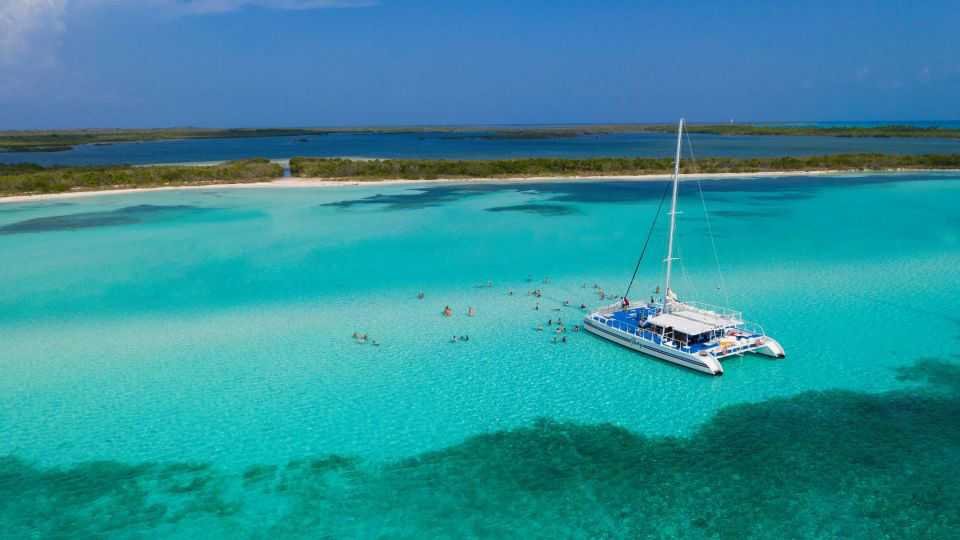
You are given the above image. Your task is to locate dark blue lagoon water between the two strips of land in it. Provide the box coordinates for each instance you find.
[0,133,960,165]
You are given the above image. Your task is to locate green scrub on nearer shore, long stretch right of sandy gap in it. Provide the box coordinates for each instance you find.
[290,154,960,180]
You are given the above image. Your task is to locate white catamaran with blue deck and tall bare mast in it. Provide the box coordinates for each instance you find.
[583,119,786,375]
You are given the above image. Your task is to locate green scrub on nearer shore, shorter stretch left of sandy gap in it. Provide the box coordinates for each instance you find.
[0,158,283,196]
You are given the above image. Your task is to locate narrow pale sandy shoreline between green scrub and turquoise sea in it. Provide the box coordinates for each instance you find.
[0,169,960,204]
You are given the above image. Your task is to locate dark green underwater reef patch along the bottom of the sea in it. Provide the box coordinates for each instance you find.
[0,355,960,539]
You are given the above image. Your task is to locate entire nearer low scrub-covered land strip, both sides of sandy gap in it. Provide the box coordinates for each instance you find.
[0,154,960,201]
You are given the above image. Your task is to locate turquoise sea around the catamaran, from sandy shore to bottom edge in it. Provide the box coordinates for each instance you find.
[0,174,960,538]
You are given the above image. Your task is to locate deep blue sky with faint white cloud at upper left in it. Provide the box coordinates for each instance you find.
[0,0,960,129]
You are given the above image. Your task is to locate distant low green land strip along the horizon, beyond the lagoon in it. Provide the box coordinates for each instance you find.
[7,124,960,152]
